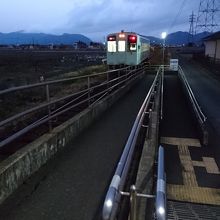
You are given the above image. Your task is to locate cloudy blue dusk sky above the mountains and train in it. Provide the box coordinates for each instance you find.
[0,0,202,41]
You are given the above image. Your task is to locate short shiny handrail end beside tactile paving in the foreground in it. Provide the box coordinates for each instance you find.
[155,146,167,220]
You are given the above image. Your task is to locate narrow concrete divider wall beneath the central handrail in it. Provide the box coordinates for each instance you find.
[135,79,160,220]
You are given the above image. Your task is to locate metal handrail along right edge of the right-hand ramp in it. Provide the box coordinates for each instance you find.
[178,66,207,124]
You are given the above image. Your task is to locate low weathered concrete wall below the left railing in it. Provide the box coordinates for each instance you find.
[0,74,143,204]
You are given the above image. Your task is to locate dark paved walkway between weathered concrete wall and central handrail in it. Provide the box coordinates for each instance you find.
[0,75,154,220]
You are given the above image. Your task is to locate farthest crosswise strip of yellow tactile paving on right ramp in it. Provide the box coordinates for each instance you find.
[160,137,201,147]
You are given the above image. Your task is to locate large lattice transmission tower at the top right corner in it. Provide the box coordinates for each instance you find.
[196,0,220,33]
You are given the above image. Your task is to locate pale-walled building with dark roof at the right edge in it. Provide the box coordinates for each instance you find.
[204,31,220,62]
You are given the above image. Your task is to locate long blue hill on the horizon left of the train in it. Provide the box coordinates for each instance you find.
[0,32,91,45]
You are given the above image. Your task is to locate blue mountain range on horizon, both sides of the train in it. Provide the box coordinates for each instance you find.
[0,31,210,45]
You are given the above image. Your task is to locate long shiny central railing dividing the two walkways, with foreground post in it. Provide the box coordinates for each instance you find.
[102,65,162,220]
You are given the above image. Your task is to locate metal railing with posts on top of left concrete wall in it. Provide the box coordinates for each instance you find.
[0,65,145,148]
